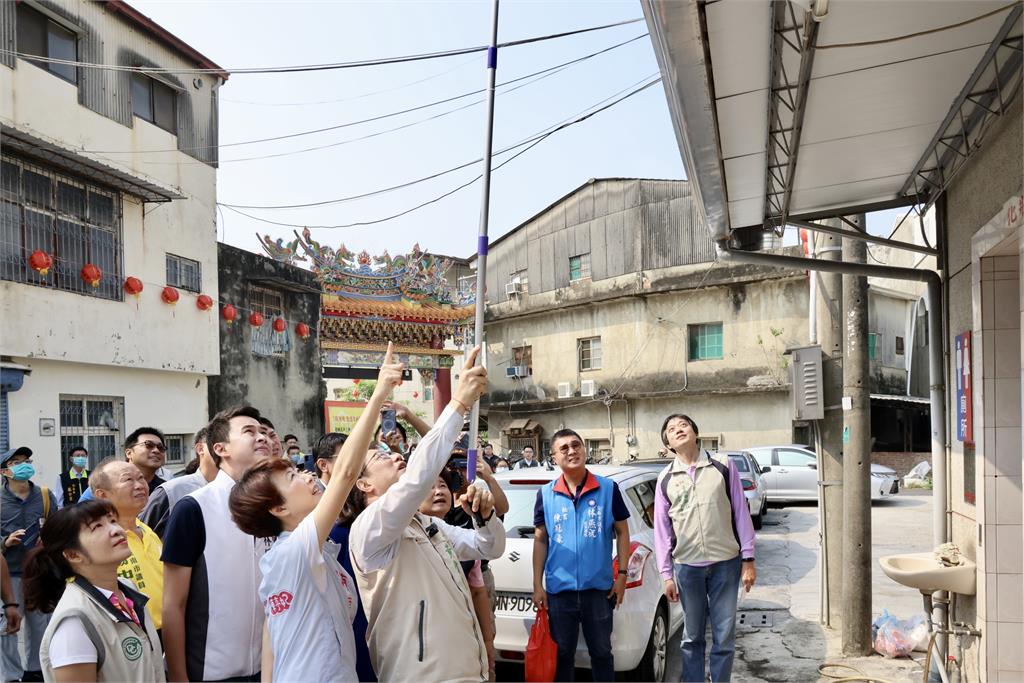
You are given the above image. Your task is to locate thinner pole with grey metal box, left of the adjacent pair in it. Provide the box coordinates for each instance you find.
[811,219,843,627]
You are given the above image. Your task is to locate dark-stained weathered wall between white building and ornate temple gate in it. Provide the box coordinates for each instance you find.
[204,244,327,449]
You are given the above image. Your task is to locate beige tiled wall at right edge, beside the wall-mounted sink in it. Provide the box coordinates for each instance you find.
[974,250,1024,683]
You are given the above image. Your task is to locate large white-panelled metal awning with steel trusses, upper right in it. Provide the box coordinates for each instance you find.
[641,0,1022,240]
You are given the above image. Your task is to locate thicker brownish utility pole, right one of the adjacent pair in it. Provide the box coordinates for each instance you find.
[842,214,871,656]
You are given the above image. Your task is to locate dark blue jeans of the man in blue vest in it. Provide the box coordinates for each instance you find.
[548,587,615,681]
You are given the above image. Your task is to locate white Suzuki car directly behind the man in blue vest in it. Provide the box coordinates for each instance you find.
[490,465,683,681]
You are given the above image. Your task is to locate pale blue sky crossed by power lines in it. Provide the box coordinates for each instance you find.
[132,0,900,257]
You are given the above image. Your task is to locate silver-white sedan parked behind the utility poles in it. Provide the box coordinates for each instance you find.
[748,444,899,503]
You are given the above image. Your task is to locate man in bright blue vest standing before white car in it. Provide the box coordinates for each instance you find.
[534,429,630,681]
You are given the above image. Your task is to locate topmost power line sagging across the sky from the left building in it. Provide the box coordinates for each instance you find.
[0,17,644,76]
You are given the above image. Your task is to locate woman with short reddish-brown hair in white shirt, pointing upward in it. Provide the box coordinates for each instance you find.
[229,343,403,683]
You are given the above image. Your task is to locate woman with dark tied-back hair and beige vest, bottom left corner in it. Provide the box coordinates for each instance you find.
[25,500,166,683]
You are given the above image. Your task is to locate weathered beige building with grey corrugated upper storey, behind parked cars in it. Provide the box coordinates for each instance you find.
[486,178,927,460]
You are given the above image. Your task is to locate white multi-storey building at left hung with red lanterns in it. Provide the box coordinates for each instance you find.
[0,0,227,483]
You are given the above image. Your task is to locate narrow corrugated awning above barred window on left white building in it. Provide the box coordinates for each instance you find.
[0,125,185,202]
